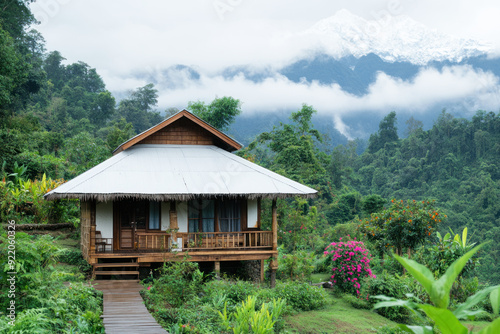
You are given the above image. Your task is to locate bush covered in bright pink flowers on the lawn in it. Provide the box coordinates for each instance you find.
[324,238,376,296]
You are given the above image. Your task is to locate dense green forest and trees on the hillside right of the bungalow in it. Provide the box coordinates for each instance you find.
[239,105,500,284]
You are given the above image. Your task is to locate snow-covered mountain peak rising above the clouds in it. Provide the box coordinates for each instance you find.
[299,9,490,65]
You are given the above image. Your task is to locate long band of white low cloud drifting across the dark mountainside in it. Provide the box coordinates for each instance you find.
[106,66,500,138]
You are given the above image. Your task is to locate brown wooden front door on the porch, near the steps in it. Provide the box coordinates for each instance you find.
[117,200,148,250]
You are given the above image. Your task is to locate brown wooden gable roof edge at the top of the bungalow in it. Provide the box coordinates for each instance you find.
[113,109,243,155]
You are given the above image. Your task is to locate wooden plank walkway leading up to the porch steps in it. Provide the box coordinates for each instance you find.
[93,280,168,334]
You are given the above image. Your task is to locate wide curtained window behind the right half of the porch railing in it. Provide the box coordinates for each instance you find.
[188,199,241,232]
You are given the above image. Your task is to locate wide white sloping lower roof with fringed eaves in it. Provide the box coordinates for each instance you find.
[45,144,317,201]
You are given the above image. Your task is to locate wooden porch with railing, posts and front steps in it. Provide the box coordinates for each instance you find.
[81,200,277,286]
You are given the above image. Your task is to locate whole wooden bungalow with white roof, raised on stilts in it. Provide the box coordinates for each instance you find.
[45,110,316,283]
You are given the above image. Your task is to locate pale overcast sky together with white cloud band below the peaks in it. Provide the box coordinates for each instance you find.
[32,0,500,136]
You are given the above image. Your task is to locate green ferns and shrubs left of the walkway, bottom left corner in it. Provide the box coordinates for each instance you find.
[0,232,104,334]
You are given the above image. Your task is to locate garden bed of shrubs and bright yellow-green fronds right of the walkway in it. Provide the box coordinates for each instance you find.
[143,261,327,333]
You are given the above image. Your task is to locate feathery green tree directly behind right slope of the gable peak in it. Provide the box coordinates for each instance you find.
[188,96,241,131]
